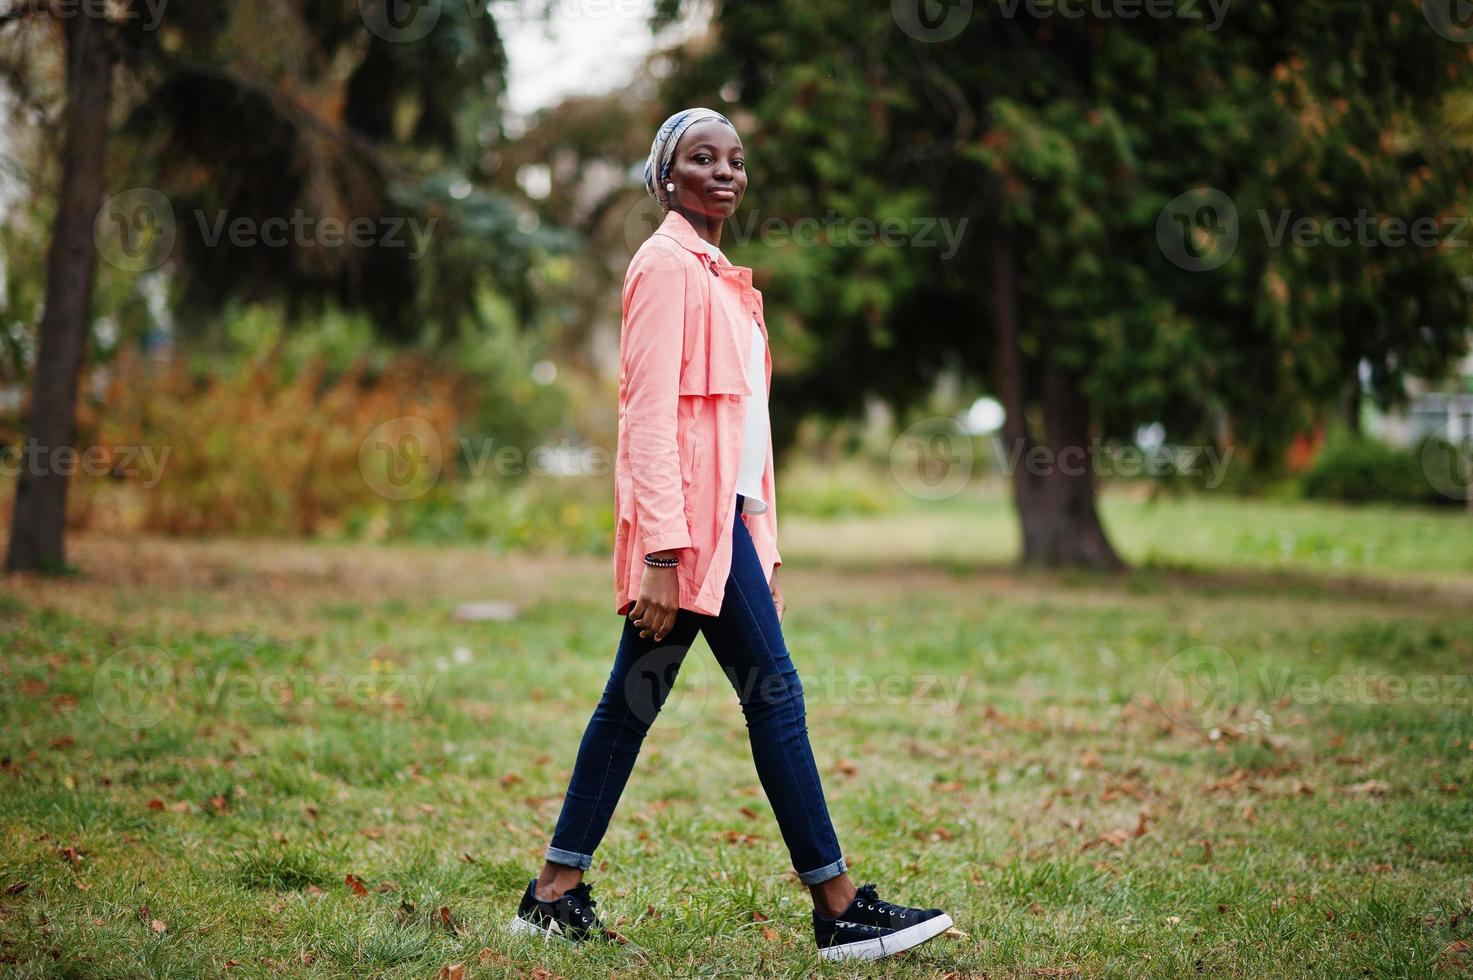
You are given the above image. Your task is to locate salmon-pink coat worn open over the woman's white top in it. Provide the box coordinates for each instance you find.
[614,211,782,616]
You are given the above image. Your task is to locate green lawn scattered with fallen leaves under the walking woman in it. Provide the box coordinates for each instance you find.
[0,497,1473,977]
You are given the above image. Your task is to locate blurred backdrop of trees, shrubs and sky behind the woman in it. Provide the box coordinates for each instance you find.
[0,0,1473,569]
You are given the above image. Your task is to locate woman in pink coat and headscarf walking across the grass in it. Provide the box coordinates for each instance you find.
[511,109,952,959]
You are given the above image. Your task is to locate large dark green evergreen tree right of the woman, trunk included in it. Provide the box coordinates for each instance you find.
[664,0,1473,567]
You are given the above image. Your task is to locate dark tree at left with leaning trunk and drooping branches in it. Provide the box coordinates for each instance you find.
[0,0,567,572]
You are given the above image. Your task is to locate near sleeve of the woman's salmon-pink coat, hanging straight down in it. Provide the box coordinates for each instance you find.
[620,251,691,554]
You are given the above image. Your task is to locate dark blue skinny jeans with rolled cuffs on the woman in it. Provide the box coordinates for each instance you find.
[546,494,848,884]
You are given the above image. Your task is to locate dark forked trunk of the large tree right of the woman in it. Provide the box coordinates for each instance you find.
[991,239,1124,570]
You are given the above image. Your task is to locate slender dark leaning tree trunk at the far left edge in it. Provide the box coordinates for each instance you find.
[6,12,112,572]
